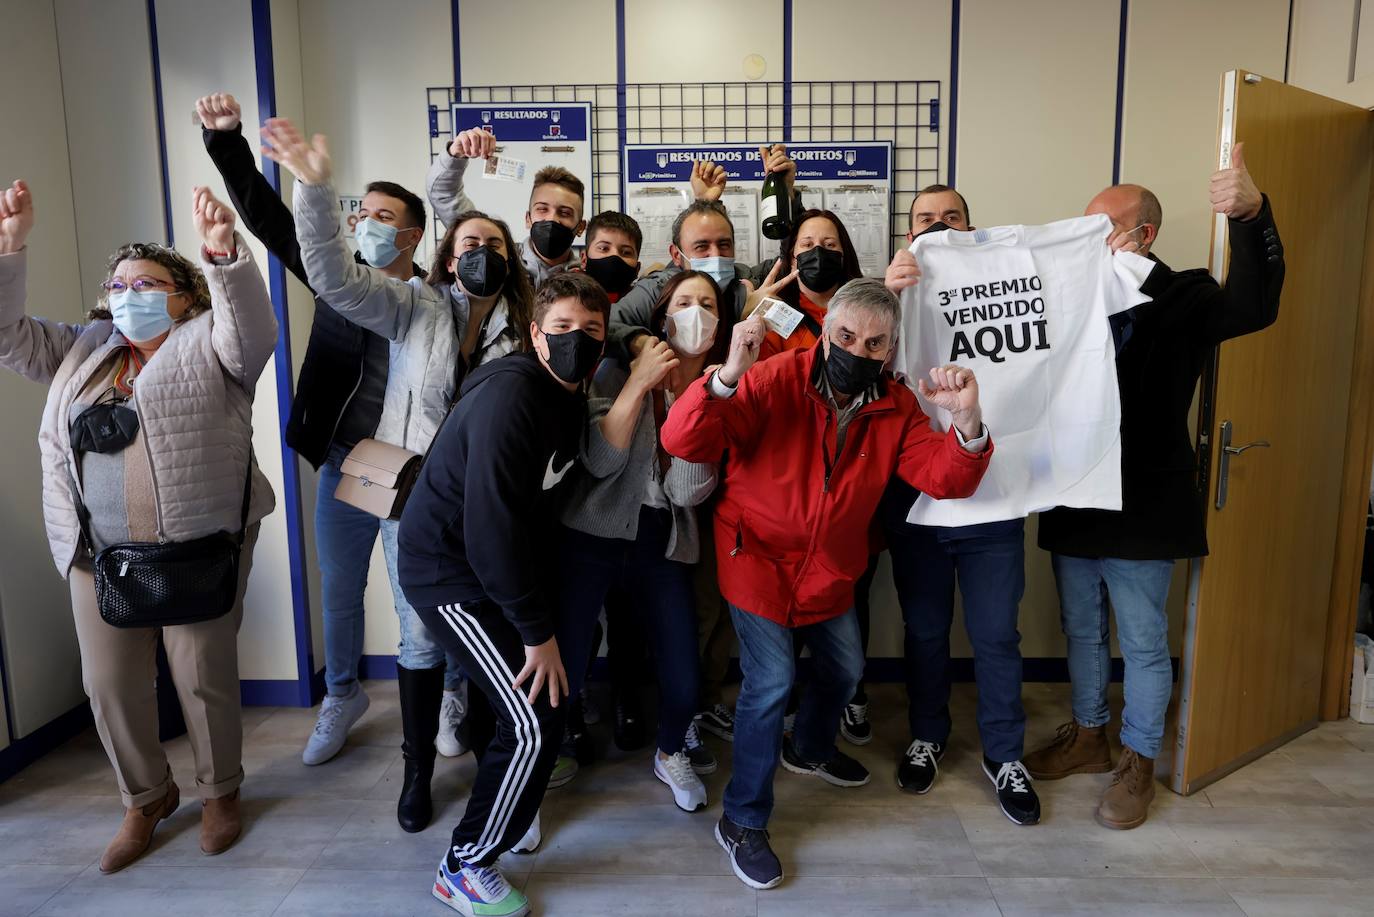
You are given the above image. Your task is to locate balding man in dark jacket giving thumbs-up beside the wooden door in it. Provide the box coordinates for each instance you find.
[1025,143,1283,829]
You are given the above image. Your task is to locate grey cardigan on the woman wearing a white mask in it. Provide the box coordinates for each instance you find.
[562,364,716,564]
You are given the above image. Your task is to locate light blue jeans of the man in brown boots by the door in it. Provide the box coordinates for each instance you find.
[1052,554,1173,758]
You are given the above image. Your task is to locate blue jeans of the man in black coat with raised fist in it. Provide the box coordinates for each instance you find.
[315,456,381,694]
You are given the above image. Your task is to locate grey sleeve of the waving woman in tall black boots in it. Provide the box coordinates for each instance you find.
[293,180,444,341]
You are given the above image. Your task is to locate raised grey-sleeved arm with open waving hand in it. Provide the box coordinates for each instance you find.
[262,118,428,341]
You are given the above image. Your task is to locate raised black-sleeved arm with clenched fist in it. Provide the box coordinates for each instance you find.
[195,92,309,285]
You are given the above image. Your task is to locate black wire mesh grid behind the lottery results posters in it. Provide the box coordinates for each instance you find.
[426,80,945,257]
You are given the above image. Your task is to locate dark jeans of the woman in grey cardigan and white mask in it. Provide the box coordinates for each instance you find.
[555,506,701,755]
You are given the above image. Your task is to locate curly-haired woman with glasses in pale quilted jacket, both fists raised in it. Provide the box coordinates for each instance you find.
[0,181,276,873]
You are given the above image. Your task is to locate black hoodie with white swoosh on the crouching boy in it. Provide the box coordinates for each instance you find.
[397,353,587,646]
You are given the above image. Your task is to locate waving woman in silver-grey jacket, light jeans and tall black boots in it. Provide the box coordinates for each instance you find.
[262,118,533,832]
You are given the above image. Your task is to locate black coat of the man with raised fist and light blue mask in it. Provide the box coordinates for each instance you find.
[201,128,422,467]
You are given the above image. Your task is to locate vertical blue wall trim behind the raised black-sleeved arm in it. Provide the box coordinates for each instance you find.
[253,0,316,707]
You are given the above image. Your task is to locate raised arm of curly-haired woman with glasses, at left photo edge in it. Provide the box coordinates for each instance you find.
[0,181,81,385]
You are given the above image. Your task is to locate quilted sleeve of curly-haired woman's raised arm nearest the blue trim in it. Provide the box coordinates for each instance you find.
[201,232,278,393]
